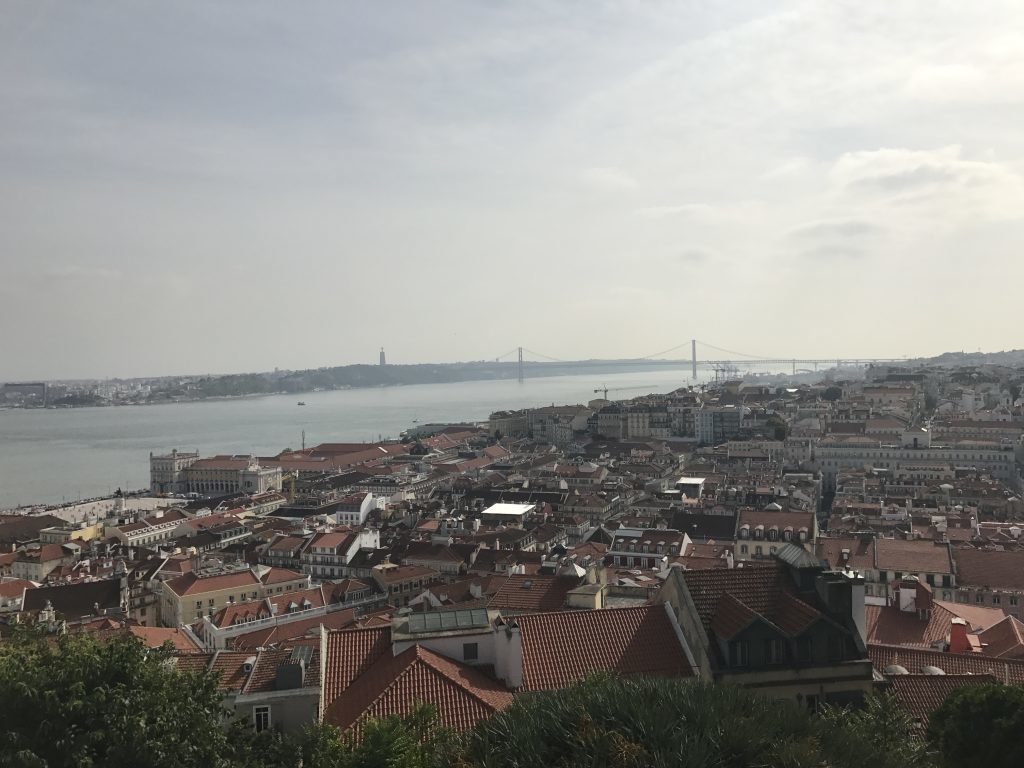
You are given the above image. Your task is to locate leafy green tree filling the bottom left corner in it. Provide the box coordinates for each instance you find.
[0,630,237,768]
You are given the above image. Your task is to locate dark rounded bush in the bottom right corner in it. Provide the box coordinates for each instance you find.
[928,683,1024,768]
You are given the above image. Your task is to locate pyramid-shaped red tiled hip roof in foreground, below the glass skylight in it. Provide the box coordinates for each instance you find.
[324,645,512,730]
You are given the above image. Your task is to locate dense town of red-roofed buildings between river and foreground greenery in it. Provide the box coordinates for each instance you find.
[6,366,1024,732]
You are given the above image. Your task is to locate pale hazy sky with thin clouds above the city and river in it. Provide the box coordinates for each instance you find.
[0,0,1024,380]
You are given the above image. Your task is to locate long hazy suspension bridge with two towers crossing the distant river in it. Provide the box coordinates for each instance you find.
[495,339,907,381]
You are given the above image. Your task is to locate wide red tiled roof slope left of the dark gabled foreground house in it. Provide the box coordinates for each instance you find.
[510,605,693,690]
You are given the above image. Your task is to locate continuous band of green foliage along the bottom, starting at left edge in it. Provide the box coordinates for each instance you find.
[0,635,937,768]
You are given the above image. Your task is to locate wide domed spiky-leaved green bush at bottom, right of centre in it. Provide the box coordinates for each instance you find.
[463,675,927,768]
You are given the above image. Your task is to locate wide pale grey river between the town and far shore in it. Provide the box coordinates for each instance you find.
[0,370,704,509]
